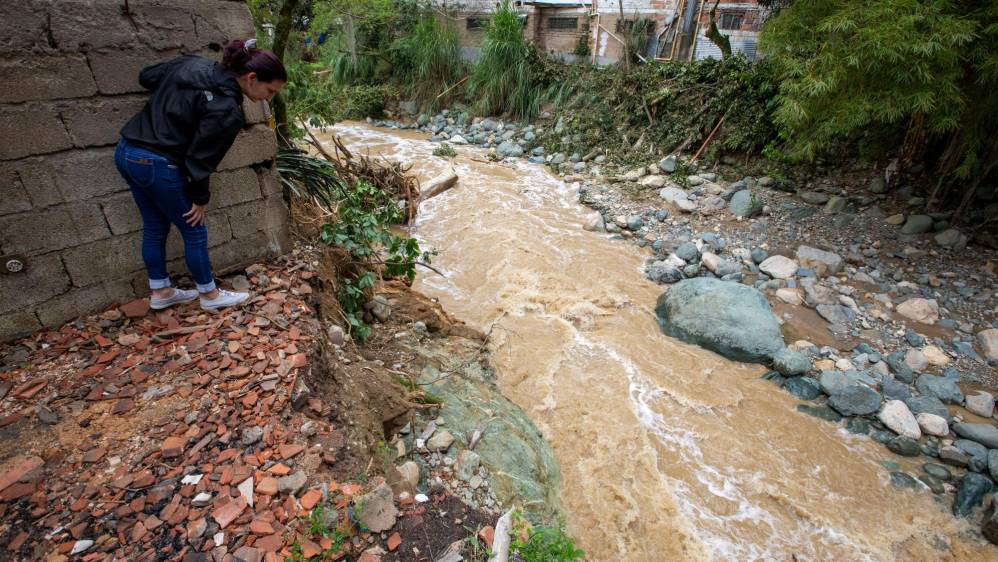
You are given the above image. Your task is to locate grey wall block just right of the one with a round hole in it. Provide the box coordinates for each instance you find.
[62,232,144,287]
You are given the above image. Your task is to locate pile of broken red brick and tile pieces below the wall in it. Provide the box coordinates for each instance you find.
[0,258,414,562]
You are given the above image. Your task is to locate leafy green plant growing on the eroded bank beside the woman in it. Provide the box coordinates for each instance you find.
[320,181,431,341]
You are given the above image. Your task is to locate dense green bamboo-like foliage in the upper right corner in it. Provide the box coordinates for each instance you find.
[762,0,998,208]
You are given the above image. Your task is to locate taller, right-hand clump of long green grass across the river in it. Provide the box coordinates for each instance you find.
[468,0,541,120]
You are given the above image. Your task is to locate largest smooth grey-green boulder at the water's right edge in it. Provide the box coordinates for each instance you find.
[655,277,785,363]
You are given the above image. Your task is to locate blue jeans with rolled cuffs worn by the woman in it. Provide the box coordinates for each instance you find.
[114,139,215,293]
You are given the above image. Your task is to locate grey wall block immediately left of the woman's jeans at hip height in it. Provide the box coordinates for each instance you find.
[50,146,128,201]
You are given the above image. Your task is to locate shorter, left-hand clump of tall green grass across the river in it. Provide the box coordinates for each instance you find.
[389,14,465,103]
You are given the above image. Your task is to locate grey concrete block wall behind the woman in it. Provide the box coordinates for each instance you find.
[0,0,289,340]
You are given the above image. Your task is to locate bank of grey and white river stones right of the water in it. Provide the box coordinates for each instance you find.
[366,112,998,542]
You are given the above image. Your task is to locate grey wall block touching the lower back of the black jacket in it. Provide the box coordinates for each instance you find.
[62,96,146,148]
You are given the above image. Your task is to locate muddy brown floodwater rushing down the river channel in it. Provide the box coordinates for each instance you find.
[335,124,994,562]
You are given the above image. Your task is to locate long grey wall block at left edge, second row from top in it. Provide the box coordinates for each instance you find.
[0,53,97,103]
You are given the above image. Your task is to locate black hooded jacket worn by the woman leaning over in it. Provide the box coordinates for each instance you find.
[121,55,245,205]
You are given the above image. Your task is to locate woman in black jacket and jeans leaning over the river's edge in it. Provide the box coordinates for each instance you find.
[114,39,288,310]
